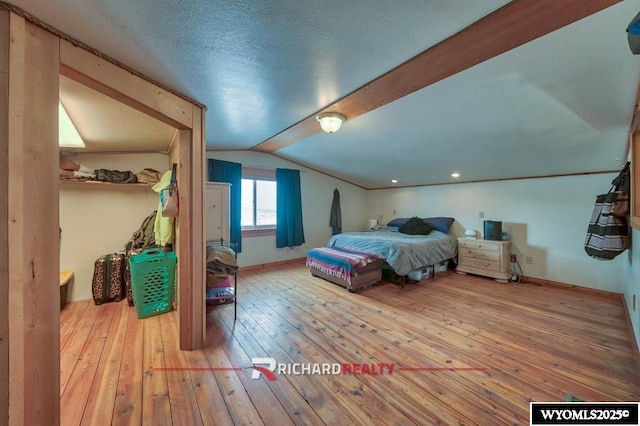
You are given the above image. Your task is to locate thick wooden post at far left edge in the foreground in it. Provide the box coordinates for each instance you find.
[0,11,60,425]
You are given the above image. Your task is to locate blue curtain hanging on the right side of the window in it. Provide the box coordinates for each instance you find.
[276,169,304,247]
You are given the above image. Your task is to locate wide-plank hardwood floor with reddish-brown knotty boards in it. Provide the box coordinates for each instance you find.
[60,265,640,425]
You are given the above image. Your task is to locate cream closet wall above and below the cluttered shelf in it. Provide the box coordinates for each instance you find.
[60,154,169,301]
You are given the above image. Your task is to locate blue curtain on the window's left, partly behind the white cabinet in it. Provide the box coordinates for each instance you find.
[208,158,242,253]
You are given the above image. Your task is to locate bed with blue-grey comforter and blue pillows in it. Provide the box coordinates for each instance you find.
[327,218,458,276]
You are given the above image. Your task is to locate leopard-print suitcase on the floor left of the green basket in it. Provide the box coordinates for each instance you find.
[91,253,125,305]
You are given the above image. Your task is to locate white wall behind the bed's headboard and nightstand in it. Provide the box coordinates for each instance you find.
[368,174,637,293]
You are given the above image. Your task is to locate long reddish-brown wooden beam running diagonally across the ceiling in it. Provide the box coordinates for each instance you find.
[252,0,621,153]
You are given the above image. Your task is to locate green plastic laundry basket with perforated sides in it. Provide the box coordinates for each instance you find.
[129,248,177,318]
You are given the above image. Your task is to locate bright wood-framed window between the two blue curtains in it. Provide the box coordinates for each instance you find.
[240,167,276,235]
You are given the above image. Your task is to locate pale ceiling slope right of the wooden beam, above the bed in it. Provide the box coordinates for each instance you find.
[278,3,640,187]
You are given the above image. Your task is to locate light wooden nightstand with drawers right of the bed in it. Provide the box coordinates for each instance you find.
[456,238,511,283]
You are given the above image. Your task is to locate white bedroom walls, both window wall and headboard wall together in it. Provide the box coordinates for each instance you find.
[207,151,640,296]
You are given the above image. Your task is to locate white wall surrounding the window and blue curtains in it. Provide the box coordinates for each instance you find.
[207,151,368,266]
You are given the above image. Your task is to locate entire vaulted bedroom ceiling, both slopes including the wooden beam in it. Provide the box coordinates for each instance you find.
[9,0,640,188]
